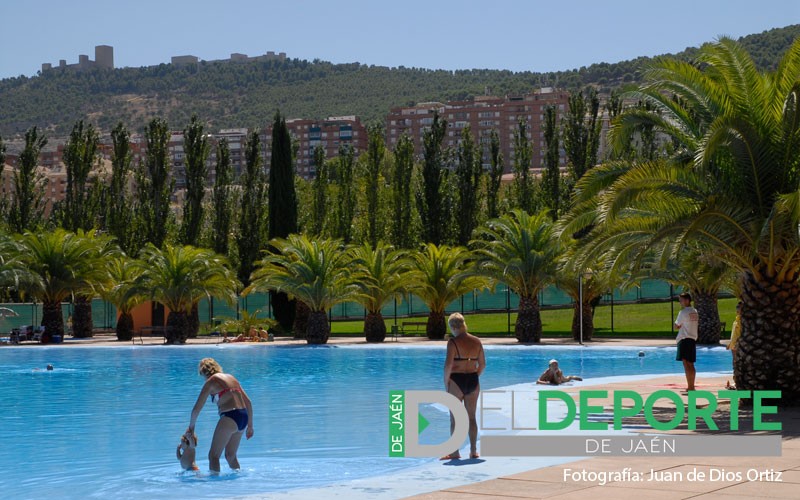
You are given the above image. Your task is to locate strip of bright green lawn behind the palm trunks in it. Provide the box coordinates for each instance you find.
[331,298,736,338]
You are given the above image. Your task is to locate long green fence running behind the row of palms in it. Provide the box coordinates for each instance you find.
[0,280,680,333]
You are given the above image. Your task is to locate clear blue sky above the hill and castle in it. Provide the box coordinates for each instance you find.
[0,0,800,78]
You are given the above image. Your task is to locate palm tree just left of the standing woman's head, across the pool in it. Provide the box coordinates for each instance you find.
[409,243,489,340]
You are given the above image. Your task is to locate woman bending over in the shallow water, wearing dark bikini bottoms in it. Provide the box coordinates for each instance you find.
[186,358,253,473]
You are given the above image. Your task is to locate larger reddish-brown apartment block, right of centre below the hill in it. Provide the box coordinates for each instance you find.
[386,88,569,172]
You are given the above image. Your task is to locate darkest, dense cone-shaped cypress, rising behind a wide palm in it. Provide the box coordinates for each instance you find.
[268,111,297,330]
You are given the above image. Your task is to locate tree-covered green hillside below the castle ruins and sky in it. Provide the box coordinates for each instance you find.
[0,25,800,137]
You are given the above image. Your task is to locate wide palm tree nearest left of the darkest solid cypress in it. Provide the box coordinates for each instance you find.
[130,244,241,344]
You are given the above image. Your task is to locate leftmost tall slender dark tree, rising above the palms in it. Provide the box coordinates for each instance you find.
[8,127,47,234]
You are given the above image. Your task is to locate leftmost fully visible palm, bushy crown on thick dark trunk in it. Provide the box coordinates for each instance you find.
[19,229,108,335]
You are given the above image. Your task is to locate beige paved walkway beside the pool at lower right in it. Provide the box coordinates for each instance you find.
[410,376,800,500]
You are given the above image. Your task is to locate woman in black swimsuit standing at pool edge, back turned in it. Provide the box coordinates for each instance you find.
[442,313,486,460]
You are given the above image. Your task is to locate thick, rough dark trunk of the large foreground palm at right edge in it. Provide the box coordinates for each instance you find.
[733,272,800,405]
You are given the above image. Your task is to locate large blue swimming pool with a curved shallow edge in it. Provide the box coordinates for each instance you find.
[0,343,730,499]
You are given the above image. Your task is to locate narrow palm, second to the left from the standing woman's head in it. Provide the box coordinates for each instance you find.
[353,242,411,342]
